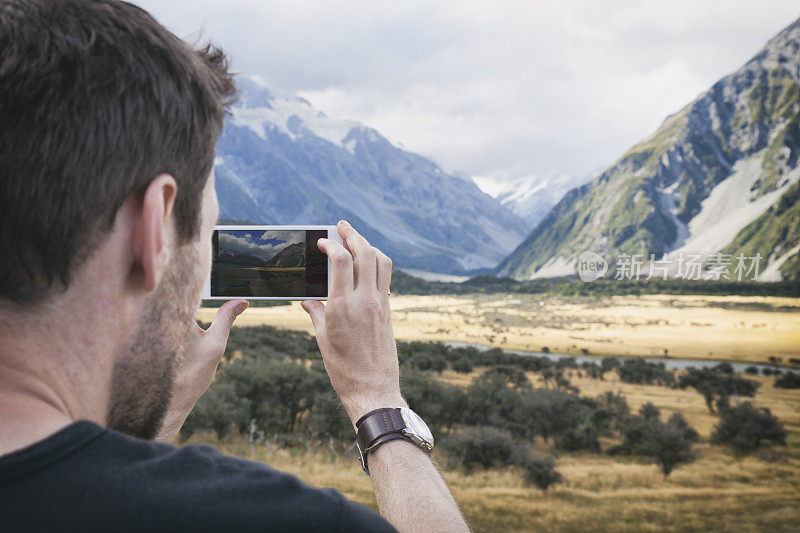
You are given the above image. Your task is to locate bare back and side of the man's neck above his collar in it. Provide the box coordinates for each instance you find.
[0,288,121,456]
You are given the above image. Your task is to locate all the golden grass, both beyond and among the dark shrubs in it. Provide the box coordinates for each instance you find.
[192,295,800,531]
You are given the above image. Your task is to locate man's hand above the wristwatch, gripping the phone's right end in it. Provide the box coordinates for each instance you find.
[303,221,406,424]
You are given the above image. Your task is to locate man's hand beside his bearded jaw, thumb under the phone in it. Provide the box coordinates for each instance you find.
[155,300,248,442]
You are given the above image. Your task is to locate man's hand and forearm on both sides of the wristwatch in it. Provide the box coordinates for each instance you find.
[303,221,468,532]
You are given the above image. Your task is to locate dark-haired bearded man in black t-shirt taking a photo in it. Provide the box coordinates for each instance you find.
[0,0,466,531]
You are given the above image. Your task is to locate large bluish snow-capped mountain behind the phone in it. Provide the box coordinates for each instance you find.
[215,77,526,273]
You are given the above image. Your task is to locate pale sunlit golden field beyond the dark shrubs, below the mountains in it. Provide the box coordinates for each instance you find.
[198,294,800,362]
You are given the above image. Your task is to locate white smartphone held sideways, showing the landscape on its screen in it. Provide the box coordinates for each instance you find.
[203,226,342,300]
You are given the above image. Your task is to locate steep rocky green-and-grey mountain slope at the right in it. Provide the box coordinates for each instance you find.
[496,20,800,279]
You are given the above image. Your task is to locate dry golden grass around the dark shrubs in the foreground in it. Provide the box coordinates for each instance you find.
[192,372,800,531]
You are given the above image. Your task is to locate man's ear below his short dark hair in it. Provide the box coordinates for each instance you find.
[133,174,178,291]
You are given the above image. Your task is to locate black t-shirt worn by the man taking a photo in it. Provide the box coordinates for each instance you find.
[0,421,396,532]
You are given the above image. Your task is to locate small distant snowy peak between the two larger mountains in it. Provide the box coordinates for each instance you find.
[472,174,591,228]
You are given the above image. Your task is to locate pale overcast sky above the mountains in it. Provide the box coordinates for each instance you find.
[134,0,800,183]
